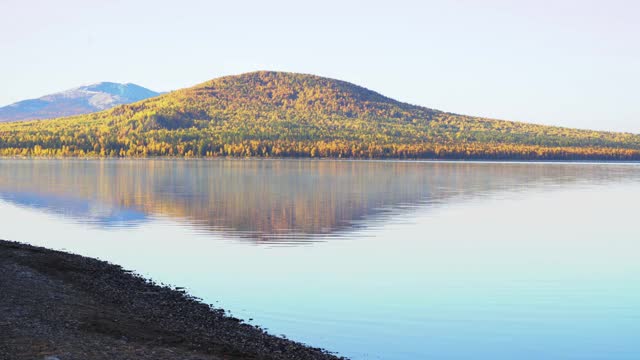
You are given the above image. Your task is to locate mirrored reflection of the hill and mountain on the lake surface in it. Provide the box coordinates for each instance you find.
[0,160,640,242]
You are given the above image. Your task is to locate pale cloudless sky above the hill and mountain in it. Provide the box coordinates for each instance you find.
[0,0,640,133]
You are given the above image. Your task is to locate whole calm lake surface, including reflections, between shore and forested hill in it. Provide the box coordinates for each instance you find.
[0,159,640,360]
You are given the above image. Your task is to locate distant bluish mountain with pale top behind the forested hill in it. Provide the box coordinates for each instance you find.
[0,82,160,122]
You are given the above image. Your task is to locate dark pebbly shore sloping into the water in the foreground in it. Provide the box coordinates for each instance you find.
[0,240,338,360]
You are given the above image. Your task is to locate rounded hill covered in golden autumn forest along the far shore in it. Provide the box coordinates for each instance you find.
[0,72,640,160]
